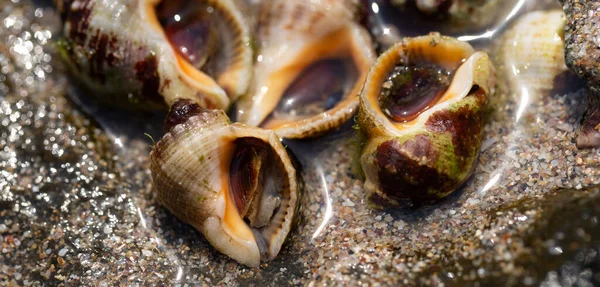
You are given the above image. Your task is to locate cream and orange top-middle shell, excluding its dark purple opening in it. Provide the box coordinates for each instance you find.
[237,0,375,138]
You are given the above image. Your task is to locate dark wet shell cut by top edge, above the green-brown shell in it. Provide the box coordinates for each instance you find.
[361,0,516,51]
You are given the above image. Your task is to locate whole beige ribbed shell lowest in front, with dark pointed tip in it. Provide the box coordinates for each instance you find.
[150,101,298,267]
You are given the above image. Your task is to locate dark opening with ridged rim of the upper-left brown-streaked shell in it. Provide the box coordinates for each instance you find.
[149,0,252,103]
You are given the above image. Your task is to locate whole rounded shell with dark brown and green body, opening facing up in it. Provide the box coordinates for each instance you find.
[358,34,494,208]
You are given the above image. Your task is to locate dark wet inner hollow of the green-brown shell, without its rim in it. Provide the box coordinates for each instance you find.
[378,65,451,122]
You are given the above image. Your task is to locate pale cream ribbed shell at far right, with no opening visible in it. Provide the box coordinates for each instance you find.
[497,10,567,99]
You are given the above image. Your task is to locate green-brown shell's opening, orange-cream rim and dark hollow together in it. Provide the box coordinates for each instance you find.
[362,36,490,135]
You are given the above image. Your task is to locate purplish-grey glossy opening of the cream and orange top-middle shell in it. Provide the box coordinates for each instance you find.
[263,58,358,126]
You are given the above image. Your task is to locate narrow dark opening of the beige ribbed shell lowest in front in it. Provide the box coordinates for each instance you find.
[229,137,290,261]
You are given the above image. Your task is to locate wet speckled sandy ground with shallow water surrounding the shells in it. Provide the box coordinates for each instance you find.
[0,0,600,286]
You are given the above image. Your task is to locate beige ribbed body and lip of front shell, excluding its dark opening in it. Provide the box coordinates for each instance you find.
[150,111,298,267]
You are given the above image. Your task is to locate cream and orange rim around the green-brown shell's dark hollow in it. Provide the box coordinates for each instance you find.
[361,34,491,137]
